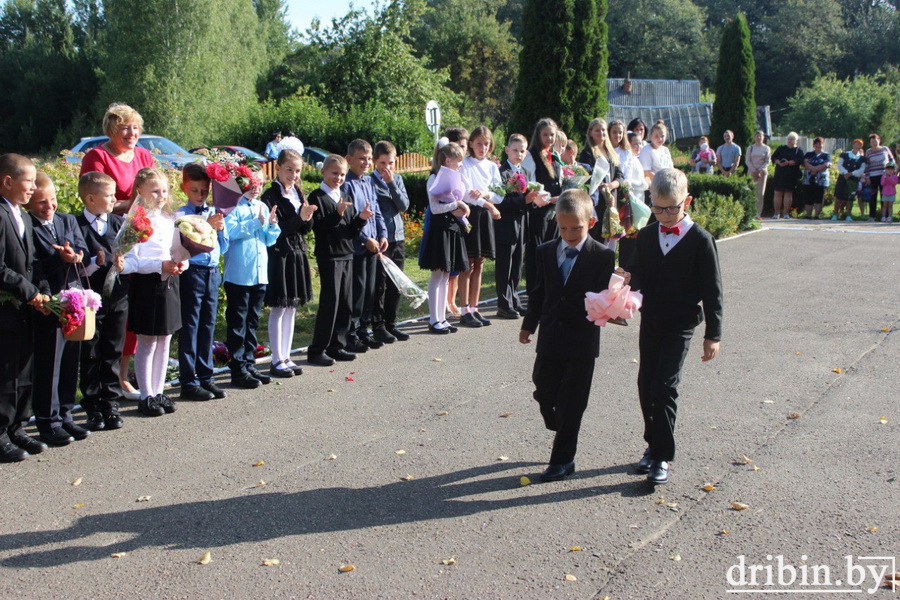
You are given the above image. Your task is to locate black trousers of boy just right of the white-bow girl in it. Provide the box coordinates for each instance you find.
[307,257,353,356]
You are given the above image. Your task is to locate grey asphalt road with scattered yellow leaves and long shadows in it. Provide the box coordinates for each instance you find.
[0,222,900,600]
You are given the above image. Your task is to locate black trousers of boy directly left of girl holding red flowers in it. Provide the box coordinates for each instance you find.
[80,300,128,413]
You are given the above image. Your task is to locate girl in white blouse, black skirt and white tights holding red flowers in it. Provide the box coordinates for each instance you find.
[117,168,188,417]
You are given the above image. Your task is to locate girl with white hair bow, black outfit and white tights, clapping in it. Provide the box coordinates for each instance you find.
[261,150,317,377]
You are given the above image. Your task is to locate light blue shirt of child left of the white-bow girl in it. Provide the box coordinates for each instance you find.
[225,198,281,286]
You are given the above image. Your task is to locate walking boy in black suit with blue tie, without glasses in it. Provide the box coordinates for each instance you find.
[519,189,616,481]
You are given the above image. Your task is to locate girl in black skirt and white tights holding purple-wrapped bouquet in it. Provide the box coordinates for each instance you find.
[419,143,469,334]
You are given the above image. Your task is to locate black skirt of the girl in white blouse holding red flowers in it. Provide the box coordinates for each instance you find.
[128,273,181,335]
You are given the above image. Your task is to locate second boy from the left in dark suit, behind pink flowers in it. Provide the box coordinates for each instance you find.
[27,173,90,446]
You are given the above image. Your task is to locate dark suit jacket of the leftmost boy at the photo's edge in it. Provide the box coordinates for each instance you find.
[0,197,50,333]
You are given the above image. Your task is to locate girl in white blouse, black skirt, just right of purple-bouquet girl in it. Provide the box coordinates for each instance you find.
[459,125,503,327]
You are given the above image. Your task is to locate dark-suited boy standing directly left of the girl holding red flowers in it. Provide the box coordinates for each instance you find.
[76,171,128,431]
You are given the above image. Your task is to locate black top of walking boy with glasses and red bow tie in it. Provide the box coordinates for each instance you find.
[624,223,723,341]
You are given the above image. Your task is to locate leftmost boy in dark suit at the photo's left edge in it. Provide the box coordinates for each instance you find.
[0,154,49,463]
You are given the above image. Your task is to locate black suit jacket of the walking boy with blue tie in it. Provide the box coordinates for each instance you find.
[522,237,616,358]
